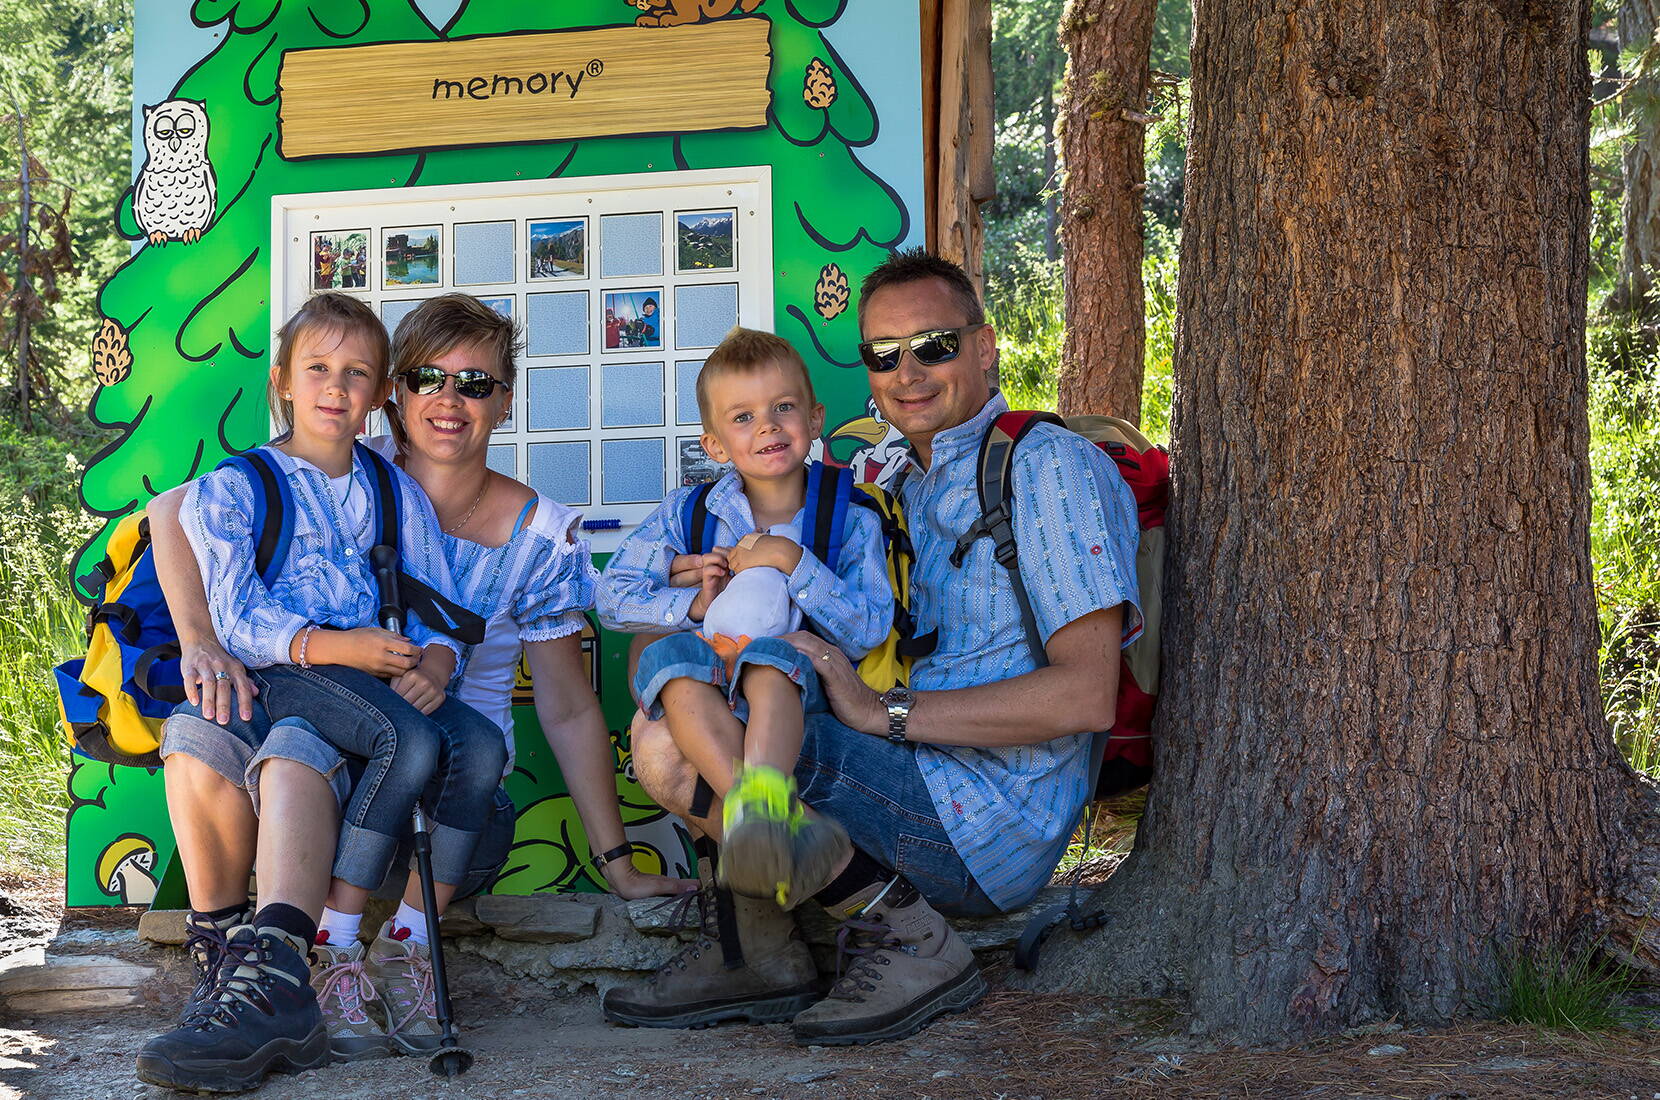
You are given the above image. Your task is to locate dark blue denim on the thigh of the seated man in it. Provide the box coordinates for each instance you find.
[795,713,1001,916]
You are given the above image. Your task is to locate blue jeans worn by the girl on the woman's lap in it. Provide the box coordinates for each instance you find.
[249,665,508,889]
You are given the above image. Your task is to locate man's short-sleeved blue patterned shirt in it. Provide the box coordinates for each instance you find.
[901,395,1140,909]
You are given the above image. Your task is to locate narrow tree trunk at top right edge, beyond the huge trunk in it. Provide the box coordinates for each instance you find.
[1609,0,1660,315]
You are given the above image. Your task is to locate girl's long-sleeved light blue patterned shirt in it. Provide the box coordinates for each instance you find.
[179,446,461,669]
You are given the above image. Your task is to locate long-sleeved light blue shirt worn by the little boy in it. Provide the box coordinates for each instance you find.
[599,471,893,660]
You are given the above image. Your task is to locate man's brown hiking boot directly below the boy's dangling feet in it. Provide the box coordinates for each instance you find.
[599,863,818,1027]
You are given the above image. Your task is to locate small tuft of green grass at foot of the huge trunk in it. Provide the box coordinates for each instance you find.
[1497,944,1635,1032]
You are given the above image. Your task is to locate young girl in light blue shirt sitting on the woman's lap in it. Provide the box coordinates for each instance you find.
[181,294,506,1057]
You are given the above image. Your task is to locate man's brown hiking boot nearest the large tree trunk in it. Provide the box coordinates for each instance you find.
[792,878,986,1047]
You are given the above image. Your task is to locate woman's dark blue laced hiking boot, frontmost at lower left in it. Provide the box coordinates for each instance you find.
[138,924,329,1092]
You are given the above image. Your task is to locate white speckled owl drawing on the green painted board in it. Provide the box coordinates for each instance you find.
[133,100,219,244]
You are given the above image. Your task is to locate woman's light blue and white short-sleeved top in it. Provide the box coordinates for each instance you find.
[364,436,599,771]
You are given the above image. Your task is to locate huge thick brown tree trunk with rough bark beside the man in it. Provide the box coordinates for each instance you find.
[1015,0,1660,1042]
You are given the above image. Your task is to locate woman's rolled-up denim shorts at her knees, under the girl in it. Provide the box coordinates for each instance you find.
[161,698,352,813]
